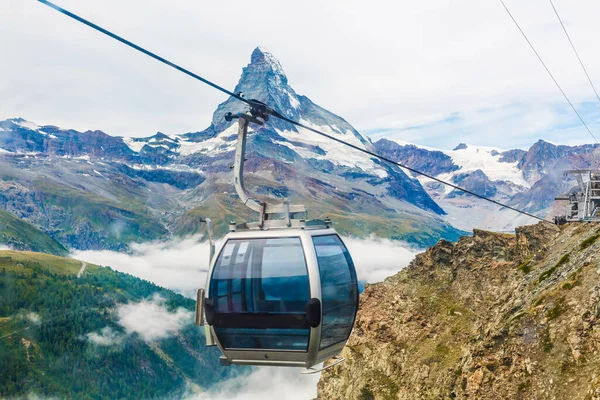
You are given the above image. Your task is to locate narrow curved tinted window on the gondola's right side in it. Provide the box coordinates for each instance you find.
[313,235,358,349]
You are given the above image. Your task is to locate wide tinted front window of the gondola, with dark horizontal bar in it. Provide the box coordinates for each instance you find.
[209,237,310,351]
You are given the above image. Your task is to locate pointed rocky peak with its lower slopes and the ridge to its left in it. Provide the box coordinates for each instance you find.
[0,48,460,249]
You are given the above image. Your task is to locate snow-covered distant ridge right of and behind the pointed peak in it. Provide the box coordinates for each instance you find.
[374,139,600,230]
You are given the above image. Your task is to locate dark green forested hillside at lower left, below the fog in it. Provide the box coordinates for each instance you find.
[0,251,247,399]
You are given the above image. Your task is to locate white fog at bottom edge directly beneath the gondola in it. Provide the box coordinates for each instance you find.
[185,367,320,400]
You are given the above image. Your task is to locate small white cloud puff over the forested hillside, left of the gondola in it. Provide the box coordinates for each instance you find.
[117,295,194,342]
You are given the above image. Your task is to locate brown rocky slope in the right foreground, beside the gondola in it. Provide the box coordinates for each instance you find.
[319,223,600,400]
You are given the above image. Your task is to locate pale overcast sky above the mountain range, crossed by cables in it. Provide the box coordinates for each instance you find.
[0,0,600,149]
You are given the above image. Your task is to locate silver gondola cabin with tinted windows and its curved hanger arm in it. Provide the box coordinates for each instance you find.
[196,103,358,372]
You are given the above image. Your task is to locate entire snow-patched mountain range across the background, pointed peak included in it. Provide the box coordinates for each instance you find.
[0,48,599,249]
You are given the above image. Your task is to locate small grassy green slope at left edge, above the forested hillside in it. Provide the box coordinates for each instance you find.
[0,208,69,256]
